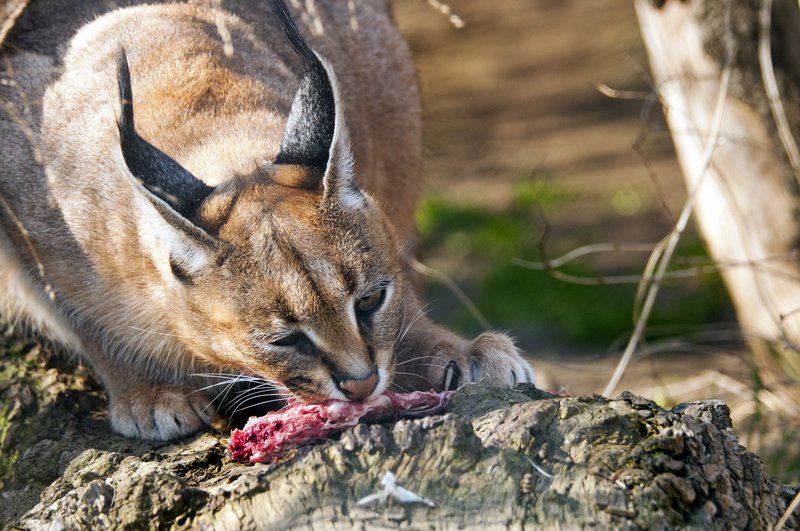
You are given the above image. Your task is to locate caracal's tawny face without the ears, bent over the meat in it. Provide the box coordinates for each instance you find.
[173,179,404,401]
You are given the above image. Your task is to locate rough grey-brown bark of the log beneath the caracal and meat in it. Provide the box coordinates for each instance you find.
[0,343,800,530]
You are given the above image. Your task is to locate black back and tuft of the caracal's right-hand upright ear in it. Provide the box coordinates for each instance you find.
[272,0,336,170]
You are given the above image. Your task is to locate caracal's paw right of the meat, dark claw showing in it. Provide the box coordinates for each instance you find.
[431,332,534,390]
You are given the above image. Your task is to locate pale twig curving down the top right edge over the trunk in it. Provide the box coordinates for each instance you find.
[758,0,800,186]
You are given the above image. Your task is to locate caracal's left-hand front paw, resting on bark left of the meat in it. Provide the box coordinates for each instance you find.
[110,385,214,441]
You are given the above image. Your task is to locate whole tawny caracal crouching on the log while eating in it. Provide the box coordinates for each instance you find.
[0,0,533,439]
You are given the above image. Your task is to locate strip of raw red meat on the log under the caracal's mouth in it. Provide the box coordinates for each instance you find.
[228,391,453,463]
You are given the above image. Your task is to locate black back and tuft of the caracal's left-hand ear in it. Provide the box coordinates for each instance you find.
[117,49,214,219]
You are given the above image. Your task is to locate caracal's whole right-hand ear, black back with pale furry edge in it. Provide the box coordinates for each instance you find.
[272,0,366,209]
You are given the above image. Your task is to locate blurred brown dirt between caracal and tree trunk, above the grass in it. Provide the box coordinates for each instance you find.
[395,0,684,220]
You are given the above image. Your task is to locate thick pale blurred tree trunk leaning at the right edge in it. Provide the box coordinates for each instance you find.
[634,0,800,415]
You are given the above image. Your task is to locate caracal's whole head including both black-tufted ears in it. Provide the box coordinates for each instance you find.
[118,2,406,400]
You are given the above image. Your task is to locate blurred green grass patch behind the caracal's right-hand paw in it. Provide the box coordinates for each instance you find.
[417,188,732,346]
